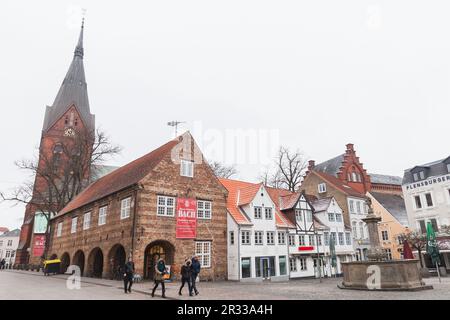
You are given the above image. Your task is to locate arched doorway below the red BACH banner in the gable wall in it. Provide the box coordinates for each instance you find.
[144,240,175,279]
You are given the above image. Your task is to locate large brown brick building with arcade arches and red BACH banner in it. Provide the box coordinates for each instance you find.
[49,133,227,280]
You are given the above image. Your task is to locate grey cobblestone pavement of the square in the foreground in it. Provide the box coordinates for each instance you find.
[0,270,450,300]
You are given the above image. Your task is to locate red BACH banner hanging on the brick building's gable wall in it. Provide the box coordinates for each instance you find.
[176,198,197,239]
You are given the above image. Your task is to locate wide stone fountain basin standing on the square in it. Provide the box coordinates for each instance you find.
[338,259,433,291]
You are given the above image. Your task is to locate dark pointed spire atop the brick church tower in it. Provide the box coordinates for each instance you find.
[43,18,95,132]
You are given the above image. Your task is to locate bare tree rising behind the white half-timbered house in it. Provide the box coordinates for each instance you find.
[273,146,308,192]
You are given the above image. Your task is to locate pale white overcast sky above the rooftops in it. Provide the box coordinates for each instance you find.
[0,0,450,228]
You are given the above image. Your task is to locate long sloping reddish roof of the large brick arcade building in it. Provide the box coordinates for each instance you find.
[56,137,181,217]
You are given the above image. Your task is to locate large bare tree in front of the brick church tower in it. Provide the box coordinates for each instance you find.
[0,130,121,256]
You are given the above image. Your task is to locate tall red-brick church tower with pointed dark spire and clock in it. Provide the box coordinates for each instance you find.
[16,20,95,264]
